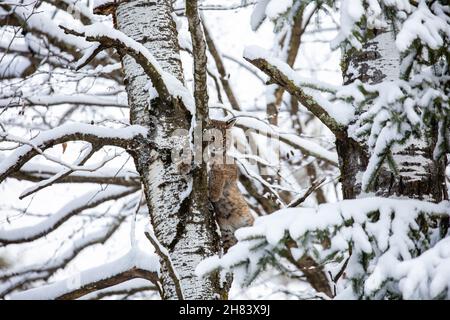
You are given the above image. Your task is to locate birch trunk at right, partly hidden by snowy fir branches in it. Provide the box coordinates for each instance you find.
[336,30,448,202]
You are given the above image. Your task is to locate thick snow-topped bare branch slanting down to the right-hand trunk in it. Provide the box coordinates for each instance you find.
[244,46,353,137]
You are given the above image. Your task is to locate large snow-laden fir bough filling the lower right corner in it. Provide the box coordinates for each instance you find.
[196,197,450,299]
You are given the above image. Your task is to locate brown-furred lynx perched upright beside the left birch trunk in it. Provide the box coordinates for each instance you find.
[208,120,253,253]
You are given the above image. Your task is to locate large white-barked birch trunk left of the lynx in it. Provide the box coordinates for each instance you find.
[114,0,225,299]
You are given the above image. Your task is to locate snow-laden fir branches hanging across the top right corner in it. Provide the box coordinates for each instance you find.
[331,0,450,52]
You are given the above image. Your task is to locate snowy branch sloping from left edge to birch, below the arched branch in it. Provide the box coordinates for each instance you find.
[0,186,138,245]
